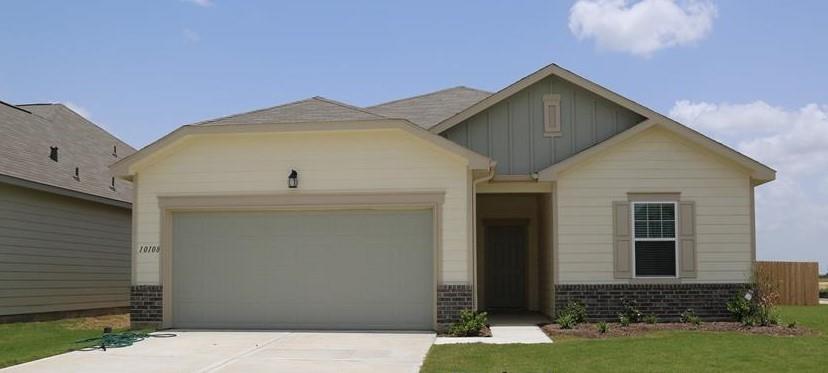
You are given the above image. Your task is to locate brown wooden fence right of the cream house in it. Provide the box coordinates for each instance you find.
[756,262,819,306]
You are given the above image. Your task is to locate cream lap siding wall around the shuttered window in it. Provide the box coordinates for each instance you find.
[556,128,753,284]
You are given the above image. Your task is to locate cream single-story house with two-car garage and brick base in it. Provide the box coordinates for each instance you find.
[113,65,775,329]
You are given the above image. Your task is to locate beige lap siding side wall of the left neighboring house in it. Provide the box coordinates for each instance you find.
[0,183,131,315]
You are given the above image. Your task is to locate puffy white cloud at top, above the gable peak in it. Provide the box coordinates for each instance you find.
[569,0,717,57]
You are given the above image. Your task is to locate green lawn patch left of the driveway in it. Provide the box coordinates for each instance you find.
[0,315,128,368]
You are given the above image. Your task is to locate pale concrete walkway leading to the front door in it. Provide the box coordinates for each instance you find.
[434,313,552,345]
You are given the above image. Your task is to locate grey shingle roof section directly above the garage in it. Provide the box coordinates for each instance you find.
[195,96,384,126]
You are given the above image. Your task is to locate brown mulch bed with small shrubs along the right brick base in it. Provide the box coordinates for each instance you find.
[541,322,813,339]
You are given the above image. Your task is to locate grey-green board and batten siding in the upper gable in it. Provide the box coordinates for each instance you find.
[441,76,644,175]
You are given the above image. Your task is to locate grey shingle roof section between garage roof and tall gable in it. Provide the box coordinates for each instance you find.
[366,86,492,129]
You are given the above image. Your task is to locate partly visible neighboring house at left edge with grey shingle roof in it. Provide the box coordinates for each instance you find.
[0,102,135,321]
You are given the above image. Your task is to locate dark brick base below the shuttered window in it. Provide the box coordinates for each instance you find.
[555,284,745,321]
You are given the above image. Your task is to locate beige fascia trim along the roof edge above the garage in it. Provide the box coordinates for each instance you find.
[110,119,494,180]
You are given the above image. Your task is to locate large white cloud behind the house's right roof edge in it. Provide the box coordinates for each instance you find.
[670,101,828,271]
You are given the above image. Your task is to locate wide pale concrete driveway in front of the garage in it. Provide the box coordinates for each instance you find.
[3,330,435,373]
